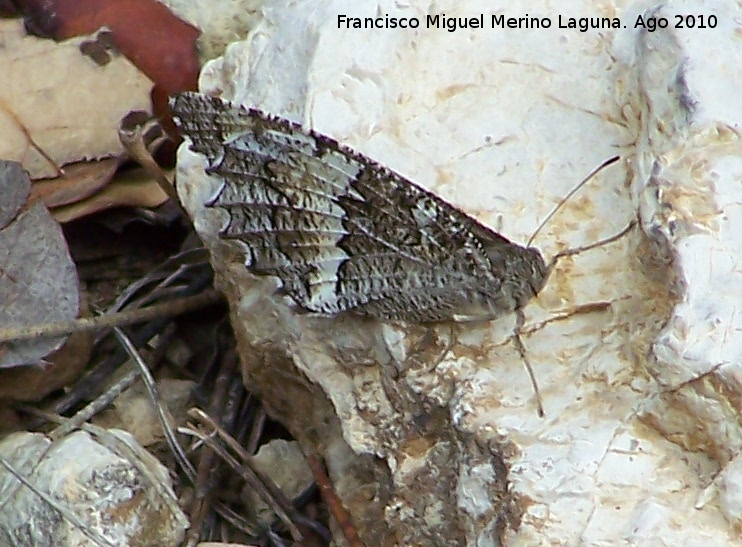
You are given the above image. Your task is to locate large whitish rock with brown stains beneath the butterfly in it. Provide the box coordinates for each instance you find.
[178,0,742,546]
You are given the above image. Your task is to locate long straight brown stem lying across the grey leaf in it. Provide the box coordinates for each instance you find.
[0,289,222,342]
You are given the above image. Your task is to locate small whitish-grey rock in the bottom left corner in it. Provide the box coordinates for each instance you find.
[0,429,188,547]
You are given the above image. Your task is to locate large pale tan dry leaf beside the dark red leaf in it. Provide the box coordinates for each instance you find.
[0,20,152,179]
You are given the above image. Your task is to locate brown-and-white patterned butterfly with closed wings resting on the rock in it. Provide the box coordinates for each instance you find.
[171,93,548,322]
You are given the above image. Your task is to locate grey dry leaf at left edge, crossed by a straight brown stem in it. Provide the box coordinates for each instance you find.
[0,162,79,368]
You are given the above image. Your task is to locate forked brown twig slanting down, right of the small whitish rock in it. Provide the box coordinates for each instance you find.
[188,408,302,541]
